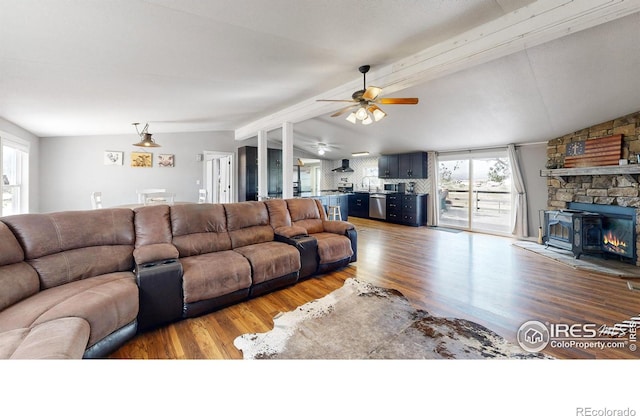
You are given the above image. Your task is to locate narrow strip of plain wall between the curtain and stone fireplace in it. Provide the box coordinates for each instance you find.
[517,143,547,239]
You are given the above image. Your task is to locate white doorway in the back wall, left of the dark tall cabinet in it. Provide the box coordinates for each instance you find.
[203,151,235,204]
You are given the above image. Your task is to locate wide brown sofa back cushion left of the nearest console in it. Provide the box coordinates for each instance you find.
[3,208,135,289]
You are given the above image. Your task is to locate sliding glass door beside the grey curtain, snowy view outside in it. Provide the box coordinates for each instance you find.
[438,149,513,234]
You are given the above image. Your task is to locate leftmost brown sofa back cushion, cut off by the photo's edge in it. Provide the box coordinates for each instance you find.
[0,222,40,311]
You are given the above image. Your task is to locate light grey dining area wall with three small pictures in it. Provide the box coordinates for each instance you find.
[40,130,240,212]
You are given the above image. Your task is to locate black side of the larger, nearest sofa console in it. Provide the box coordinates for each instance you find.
[135,259,184,332]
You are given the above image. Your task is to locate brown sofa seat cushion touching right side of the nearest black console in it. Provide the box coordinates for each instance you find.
[180,250,251,303]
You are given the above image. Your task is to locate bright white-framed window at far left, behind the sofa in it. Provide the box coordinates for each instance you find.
[0,137,29,216]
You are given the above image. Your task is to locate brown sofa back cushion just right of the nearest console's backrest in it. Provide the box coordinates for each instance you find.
[171,204,231,257]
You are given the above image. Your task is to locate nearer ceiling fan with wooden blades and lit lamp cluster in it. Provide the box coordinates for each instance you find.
[317,65,418,124]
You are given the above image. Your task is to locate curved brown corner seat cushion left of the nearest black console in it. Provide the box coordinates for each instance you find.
[0,272,138,347]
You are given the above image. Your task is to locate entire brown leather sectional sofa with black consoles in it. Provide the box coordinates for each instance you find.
[0,199,357,359]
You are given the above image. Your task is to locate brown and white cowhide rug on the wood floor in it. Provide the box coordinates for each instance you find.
[234,279,548,359]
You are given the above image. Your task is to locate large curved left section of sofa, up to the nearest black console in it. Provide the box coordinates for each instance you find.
[0,209,138,358]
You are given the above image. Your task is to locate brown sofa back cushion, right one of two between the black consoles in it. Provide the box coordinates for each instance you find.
[224,201,274,248]
